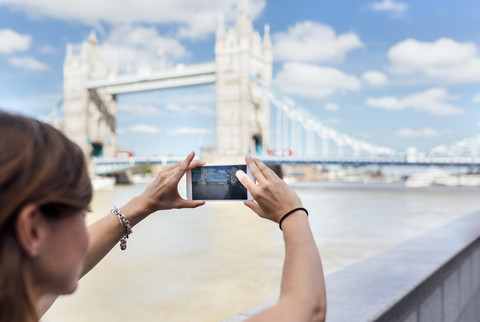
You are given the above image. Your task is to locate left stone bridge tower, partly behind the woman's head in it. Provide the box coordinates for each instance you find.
[63,33,117,157]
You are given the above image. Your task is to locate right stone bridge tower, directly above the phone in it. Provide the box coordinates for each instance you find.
[215,7,273,156]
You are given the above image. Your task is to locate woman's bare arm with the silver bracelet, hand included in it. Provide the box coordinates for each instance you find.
[39,152,205,315]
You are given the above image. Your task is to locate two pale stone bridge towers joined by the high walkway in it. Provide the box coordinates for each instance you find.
[63,9,273,161]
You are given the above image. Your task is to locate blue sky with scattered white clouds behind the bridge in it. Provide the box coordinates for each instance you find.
[0,0,480,155]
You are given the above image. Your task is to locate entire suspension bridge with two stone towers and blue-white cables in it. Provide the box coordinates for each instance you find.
[52,10,480,174]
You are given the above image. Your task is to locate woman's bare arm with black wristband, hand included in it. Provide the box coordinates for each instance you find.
[237,157,326,321]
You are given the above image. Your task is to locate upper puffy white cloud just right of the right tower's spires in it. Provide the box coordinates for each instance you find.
[272,21,364,62]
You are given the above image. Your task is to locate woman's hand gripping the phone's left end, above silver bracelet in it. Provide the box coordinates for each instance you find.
[138,152,205,214]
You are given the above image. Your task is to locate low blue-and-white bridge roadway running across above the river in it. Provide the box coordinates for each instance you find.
[93,156,480,175]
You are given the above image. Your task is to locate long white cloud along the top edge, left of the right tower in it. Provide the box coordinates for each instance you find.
[0,0,266,39]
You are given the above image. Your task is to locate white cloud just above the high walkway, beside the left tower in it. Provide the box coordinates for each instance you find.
[99,25,189,68]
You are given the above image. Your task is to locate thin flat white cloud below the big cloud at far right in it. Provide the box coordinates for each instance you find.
[366,88,464,116]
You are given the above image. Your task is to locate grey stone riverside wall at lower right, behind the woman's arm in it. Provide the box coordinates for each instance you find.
[228,213,480,322]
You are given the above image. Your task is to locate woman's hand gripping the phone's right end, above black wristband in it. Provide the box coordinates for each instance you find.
[236,156,302,223]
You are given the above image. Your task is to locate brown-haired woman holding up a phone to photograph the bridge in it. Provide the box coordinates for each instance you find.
[0,111,325,322]
